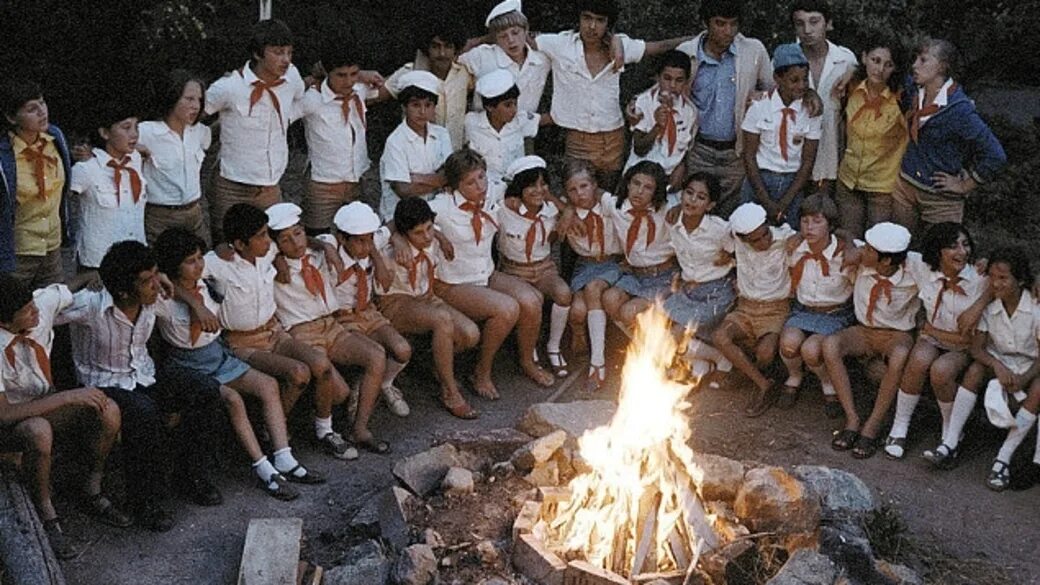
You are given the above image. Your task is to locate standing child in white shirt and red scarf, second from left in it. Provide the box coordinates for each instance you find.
[70,104,147,270]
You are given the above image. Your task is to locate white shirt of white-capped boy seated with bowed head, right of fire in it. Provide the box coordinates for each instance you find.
[733,224,795,302]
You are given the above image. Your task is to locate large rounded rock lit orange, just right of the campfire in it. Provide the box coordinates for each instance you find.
[733,467,820,534]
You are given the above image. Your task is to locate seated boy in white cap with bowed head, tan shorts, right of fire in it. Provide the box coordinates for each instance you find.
[711,203,795,417]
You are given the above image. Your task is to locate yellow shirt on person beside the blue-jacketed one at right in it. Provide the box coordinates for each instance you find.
[838,81,907,193]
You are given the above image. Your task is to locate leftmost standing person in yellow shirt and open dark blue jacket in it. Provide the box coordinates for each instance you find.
[0,78,72,288]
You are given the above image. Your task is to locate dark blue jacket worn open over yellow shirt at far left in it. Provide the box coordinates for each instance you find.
[0,124,72,273]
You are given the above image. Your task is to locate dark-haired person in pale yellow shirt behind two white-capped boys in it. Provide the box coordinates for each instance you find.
[380,25,473,148]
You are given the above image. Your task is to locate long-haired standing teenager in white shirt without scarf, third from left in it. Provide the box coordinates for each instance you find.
[137,69,211,244]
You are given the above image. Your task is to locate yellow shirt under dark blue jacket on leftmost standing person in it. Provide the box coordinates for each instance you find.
[10,133,66,256]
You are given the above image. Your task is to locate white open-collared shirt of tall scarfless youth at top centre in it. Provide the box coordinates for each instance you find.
[536,30,646,132]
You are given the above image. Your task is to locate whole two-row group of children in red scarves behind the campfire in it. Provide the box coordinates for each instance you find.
[0,0,1023,557]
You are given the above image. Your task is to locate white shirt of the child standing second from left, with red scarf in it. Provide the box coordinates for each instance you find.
[70,148,148,269]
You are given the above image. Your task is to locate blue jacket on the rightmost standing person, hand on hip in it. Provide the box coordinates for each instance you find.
[900,82,1008,190]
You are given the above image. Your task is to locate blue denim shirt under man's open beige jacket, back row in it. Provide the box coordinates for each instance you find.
[691,36,736,142]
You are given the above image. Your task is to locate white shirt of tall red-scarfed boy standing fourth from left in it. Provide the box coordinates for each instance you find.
[200,63,304,186]
